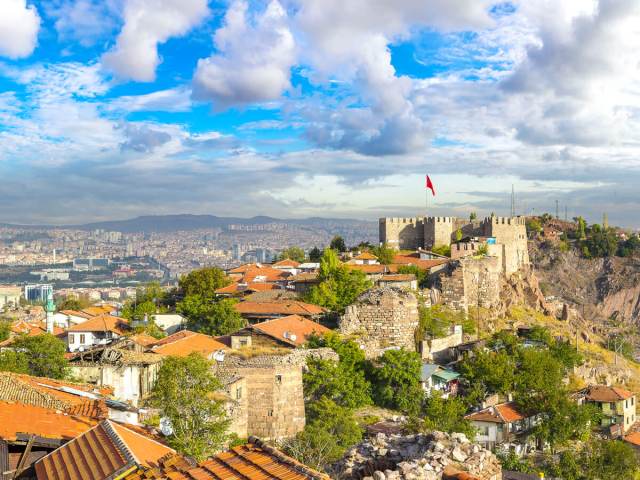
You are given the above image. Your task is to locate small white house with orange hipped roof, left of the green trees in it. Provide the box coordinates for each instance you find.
[67,314,129,352]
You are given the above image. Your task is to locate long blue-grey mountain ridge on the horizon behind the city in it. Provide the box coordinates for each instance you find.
[66,214,375,233]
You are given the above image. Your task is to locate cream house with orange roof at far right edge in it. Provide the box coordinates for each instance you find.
[574,385,636,436]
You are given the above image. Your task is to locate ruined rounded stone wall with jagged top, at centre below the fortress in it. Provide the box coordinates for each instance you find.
[339,287,419,358]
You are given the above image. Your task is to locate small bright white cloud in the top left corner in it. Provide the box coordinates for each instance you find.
[0,0,40,58]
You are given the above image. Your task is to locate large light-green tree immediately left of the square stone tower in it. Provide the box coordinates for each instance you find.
[151,353,229,461]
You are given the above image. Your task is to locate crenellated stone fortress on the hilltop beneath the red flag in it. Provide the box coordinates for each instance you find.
[379,216,529,276]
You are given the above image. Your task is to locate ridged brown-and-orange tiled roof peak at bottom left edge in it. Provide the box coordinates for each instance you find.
[35,420,175,480]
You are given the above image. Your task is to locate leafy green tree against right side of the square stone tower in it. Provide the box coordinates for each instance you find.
[303,332,371,408]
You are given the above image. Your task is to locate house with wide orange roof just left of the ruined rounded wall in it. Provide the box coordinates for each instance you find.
[231,315,331,349]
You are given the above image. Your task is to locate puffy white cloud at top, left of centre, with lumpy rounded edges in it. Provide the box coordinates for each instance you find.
[194,0,295,110]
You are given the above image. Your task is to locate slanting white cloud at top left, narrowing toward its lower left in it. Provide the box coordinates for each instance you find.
[102,0,209,82]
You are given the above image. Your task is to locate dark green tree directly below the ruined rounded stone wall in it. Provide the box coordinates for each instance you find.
[370,349,424,414]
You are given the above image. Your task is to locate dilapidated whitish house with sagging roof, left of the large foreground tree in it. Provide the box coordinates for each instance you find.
[69,338,163,407]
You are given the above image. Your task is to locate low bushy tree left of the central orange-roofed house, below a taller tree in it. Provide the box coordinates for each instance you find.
[177,295,246,335]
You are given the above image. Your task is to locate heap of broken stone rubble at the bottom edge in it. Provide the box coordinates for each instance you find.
[332,431,502,480]
